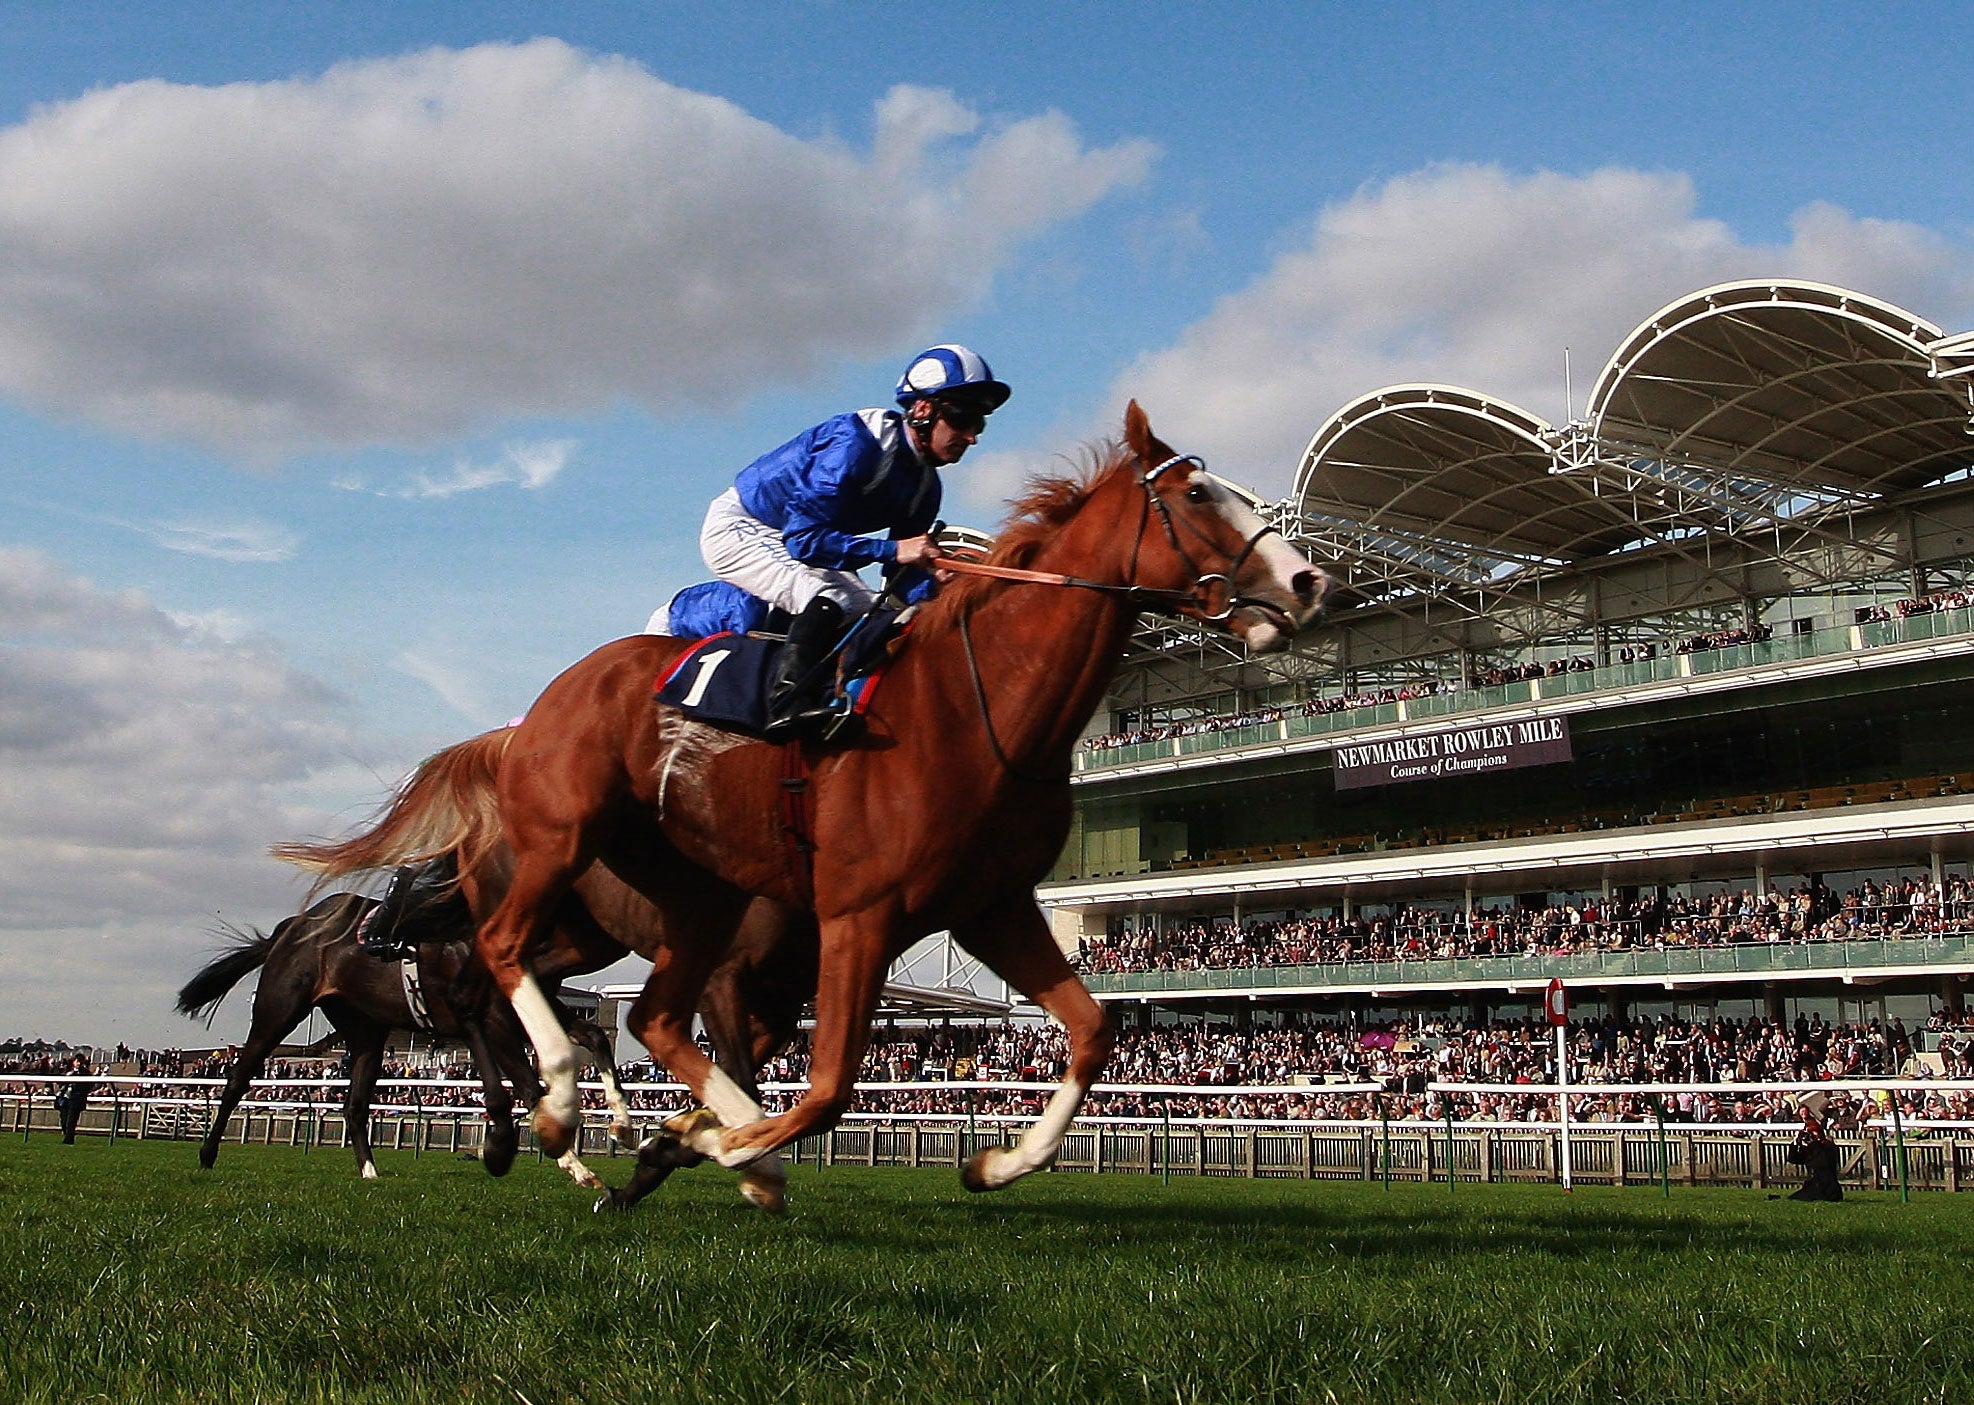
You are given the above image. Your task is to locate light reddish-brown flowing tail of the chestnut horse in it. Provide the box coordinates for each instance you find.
[268,726,513,890]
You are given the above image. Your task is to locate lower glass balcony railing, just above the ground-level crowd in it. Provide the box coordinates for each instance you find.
[1084,931,1974,995]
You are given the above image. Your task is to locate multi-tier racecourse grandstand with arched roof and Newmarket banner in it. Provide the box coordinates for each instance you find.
[1042,282,1974,1028]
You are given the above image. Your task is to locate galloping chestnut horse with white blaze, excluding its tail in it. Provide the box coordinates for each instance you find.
[467,403,1330,1190]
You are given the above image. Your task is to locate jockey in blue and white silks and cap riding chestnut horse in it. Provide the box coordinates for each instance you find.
[699,345,1011,742]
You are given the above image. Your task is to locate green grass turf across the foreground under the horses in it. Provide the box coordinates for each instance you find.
[0,1135,1974,1405]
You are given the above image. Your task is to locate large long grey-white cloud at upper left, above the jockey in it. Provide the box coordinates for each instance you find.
[0,39,1153,458]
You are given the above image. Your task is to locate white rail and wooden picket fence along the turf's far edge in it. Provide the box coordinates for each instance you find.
[15,1073,1974,1192]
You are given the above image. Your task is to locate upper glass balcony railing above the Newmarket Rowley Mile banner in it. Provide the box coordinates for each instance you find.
[1076,606,1974,774]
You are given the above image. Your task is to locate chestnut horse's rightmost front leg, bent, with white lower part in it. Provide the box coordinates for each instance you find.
[953,902,1115,1190]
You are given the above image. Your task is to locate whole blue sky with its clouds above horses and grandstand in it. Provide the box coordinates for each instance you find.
[0,2,1974,1044]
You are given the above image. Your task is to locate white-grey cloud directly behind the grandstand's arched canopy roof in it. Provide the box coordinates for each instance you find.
[1105,166,1974,493]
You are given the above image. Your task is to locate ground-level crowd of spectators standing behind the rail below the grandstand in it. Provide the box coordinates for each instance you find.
[607,1014,1974,1127]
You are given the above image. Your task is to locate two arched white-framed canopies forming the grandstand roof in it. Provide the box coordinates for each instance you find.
[1287,280,1974,594]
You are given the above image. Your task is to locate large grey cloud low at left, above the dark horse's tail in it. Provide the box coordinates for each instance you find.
[0,547,377,1044]
